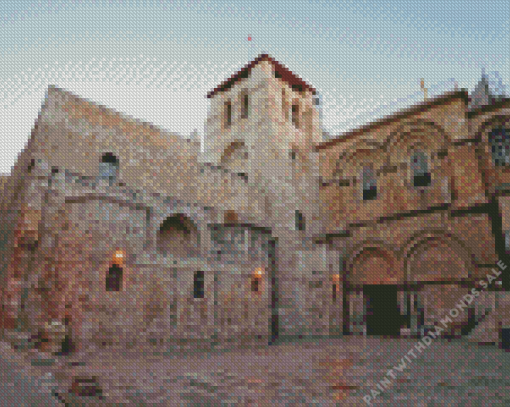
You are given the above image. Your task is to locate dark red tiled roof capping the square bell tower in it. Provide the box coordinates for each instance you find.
[207,54,316,98]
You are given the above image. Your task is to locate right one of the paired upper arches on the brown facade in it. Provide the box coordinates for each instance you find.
[383,119,451,163]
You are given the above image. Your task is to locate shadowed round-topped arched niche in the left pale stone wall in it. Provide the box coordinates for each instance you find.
[156,212,200,257]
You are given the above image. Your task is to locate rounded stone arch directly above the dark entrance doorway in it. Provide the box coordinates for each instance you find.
[344,241,404,286]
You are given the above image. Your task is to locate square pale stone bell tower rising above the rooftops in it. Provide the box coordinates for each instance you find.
[201,54,322,184]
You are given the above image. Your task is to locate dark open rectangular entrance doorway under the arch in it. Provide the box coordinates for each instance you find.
[363,284,402,336]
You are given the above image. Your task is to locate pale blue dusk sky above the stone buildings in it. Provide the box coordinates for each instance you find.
[0,0,510,173]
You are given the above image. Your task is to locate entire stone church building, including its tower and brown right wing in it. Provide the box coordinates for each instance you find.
[0,55,510,356]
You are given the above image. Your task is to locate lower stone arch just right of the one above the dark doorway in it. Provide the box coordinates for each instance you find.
[401,230,476,283]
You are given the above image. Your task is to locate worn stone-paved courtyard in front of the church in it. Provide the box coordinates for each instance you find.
[2,337,510,406]
